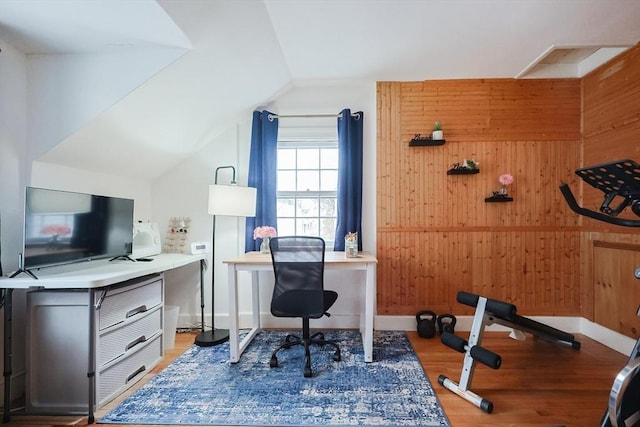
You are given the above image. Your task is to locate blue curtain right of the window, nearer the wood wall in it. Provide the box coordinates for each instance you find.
[333,109,364,251]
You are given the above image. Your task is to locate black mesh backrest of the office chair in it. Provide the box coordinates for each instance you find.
[269,236,325,318]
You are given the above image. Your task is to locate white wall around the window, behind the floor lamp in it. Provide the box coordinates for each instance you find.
[152,83,376,327]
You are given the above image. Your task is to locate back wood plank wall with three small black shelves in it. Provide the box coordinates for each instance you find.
[377,79,582,315]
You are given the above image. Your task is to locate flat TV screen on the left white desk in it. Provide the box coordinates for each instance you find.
[22,187,133,270]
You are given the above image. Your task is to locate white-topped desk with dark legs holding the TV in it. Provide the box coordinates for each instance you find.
[0,254,205,423]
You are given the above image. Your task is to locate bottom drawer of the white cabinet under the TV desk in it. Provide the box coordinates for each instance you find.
[96,334,162,408]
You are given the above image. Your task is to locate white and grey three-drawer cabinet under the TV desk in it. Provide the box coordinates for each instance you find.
[26,274,164,414]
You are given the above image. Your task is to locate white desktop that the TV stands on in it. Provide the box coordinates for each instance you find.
[0,254,206,289]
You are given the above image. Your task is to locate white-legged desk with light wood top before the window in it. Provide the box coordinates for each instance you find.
[223,251,377,363]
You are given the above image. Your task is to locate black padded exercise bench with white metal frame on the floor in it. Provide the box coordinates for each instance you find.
[438,291,580,414]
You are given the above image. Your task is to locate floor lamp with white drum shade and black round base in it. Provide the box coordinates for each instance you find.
[195,166,256,347]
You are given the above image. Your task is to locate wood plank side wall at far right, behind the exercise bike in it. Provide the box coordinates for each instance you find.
[582,44,640,338]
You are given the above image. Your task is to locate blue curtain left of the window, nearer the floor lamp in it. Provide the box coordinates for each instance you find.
[245,111,278,252]
